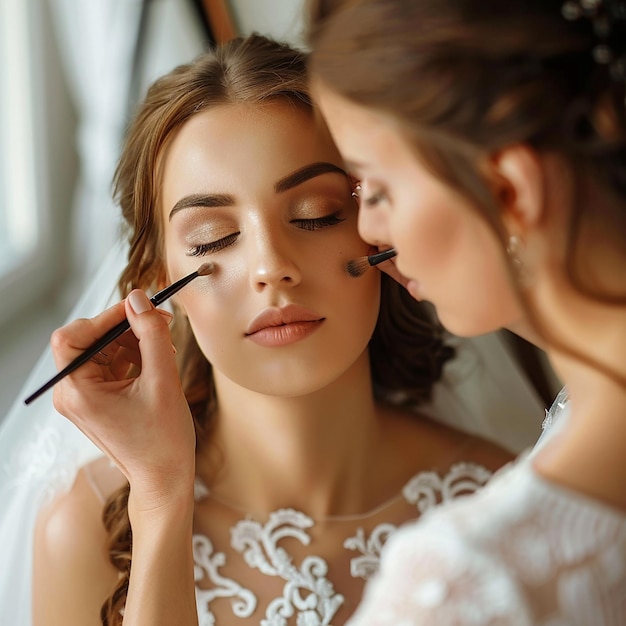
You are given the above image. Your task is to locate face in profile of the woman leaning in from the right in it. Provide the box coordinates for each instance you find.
[314,83,522,336]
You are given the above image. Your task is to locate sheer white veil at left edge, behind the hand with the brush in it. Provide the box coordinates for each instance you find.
[0,236,126,626]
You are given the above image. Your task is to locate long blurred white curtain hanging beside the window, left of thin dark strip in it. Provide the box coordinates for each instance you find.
[49,0,142,279]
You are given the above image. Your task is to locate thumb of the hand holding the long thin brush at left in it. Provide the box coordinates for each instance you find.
[126,289,177,378]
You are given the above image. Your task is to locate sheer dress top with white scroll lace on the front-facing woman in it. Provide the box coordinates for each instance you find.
[188,463,491,626]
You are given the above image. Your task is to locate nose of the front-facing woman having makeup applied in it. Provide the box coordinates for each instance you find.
[250,234,302,291]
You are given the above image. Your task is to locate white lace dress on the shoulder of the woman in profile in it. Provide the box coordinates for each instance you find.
[349,392,626,626]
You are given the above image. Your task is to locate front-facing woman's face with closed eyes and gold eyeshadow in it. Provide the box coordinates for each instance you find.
[161,102,380,396]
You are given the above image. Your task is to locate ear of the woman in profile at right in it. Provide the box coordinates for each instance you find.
[491,145,545,237]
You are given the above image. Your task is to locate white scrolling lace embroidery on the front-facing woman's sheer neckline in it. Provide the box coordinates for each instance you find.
[194,463,491,626]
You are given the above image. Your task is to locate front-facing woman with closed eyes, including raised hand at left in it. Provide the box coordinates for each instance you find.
[33,36,511,626]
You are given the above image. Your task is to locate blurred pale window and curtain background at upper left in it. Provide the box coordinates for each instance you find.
[0,0,304,421]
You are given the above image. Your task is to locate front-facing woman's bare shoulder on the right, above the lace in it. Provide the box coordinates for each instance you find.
[378,409,515,472]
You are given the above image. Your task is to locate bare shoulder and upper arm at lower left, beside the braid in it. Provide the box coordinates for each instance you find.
[33,459,123,626]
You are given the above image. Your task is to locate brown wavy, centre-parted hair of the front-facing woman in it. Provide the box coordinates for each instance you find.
[101,35,453,625]
